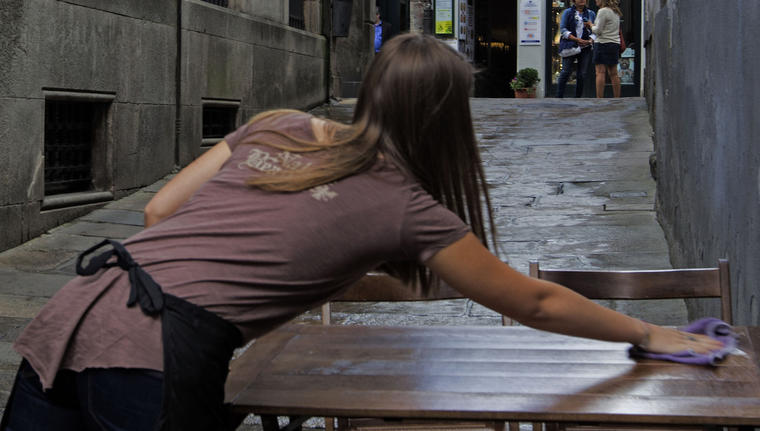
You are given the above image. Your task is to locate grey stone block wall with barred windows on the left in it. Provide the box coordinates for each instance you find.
[0,0,327,250]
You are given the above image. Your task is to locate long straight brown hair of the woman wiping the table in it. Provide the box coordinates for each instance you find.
[242,34,496,294]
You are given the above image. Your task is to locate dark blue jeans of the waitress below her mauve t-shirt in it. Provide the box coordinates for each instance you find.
[3,361,163,431]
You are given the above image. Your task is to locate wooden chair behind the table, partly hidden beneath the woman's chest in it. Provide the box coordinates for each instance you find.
[321,273,505,431]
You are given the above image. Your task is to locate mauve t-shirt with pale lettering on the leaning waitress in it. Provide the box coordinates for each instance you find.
[14,112,469,388]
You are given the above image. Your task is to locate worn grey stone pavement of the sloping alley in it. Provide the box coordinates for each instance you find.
[0,98,686,430]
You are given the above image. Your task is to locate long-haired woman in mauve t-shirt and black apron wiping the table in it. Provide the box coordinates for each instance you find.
[0,34,722,431]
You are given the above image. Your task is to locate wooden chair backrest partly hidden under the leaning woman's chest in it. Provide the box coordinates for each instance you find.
[322,273,464,325]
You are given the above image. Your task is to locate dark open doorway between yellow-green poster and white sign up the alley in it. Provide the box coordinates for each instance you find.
[474,0,517,97]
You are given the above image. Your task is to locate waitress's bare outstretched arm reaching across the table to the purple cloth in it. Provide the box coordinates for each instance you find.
[426,234,722,353]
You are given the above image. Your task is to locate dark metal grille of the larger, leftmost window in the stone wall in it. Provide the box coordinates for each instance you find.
[45,100,95,195]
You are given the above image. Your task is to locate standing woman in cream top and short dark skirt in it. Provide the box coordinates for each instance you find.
[591,0,623,98]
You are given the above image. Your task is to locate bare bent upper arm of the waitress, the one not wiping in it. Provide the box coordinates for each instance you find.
[144,141,231,227]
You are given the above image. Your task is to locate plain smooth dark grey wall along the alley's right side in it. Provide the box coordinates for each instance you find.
[645,0,760,325]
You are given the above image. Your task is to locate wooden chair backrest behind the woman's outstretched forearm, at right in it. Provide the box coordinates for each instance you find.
[530,259,733,324]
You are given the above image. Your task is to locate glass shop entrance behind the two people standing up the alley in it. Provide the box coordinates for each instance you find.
[544,0,641,97]
